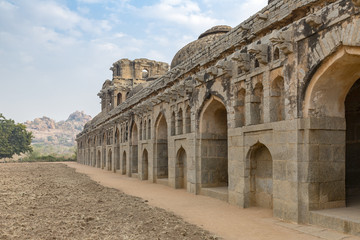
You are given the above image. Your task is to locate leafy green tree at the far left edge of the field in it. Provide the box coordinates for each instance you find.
[0,114,33,159]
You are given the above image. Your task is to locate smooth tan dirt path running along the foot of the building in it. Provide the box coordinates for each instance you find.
[67,163,360,240]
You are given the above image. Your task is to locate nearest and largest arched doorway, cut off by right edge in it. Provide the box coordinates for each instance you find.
[303,46,360,210]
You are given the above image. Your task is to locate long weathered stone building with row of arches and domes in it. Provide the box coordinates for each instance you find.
[77,0,360,234]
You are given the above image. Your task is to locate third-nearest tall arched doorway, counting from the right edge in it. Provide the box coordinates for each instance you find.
[156,114,169,179]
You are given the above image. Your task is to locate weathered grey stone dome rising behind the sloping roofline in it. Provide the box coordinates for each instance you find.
[171,25,231,68]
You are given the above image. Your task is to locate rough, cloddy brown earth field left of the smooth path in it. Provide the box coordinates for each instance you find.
[0,163,217,239]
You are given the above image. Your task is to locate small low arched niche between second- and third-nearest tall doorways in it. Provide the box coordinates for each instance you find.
[175,147,187,189]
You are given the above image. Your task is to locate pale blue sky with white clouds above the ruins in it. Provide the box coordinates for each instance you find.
[0,0,267,122]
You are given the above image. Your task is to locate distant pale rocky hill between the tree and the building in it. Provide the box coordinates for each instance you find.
[24,111,91,155]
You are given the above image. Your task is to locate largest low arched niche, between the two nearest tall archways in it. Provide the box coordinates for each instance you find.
[249,143,273,209]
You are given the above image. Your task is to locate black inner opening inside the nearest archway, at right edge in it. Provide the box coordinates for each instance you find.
[345,79,360,206]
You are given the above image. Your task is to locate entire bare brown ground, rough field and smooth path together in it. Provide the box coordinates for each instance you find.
[0,163,360,240]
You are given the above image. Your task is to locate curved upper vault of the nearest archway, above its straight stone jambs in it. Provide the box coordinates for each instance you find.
[303,47,360,118]
